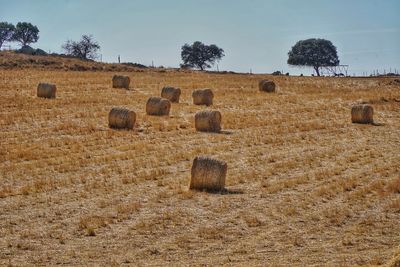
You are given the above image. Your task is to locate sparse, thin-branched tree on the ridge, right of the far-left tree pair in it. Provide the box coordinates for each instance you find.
[62,35,100,59]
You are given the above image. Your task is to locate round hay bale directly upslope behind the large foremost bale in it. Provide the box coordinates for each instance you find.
[194,110,222,132]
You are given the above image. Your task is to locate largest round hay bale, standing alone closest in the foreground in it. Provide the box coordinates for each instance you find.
[189,156,228,191]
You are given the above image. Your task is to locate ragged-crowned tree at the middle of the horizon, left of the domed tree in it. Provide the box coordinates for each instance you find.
[181,41,225,70]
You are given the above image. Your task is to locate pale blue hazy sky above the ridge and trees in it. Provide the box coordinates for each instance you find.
[0,0,400,74]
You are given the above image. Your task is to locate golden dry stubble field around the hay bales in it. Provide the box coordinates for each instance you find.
[0,62,400,266]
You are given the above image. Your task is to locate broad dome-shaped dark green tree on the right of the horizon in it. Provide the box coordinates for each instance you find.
[287,39,339,76]
